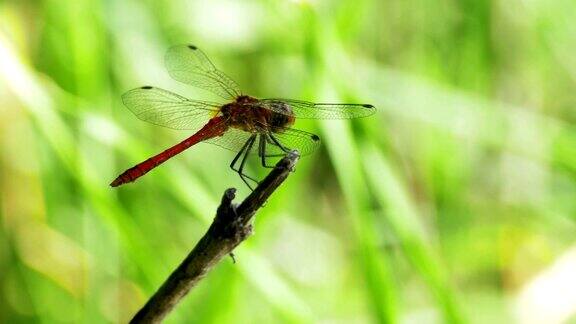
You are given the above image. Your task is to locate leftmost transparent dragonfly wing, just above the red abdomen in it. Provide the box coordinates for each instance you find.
[122,86,221,130]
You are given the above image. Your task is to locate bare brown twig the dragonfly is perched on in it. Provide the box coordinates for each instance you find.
[130,151,299,323]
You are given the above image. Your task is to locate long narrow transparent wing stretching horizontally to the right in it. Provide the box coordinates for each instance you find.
[256,99,376,119]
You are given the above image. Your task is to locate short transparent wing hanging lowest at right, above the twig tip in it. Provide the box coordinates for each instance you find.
[265,128,320,156]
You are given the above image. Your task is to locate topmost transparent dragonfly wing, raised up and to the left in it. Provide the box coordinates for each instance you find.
[165,45,240,99]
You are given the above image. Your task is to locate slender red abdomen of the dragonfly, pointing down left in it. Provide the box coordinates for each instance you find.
[110,116,228,187]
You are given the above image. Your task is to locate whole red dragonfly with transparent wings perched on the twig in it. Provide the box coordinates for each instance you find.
[110,45,376,190]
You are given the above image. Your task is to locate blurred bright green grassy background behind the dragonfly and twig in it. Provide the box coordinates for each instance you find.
[0,0,576,323]
